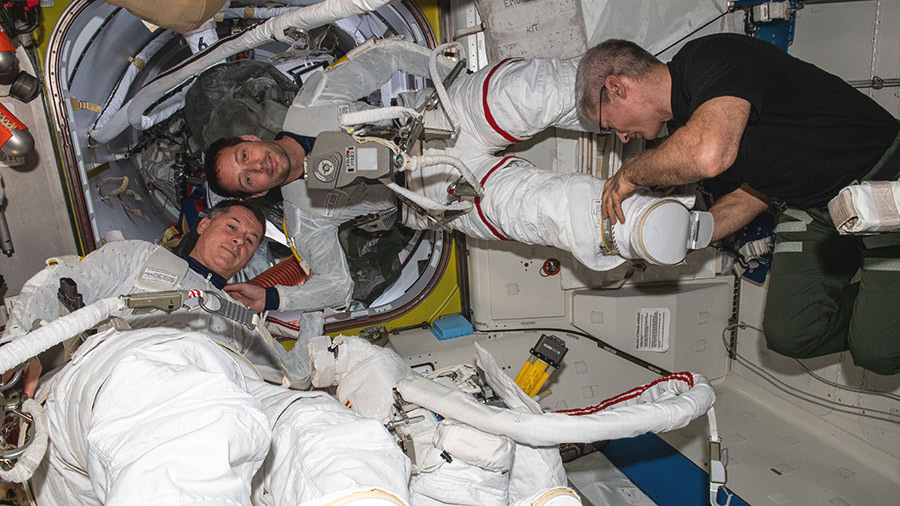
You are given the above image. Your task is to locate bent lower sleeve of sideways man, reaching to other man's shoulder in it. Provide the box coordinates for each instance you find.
[276,210,353,311]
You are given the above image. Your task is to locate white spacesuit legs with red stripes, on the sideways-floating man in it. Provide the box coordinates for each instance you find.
[403,58,712,271]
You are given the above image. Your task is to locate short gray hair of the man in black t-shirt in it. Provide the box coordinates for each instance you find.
[575,39,662,118]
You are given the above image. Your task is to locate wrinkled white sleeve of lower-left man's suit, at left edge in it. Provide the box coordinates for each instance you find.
[3,241,160,342]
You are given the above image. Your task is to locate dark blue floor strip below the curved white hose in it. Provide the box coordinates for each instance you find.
[603,434,749,506]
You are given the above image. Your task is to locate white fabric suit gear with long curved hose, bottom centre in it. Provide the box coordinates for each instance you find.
[309,336,715,506]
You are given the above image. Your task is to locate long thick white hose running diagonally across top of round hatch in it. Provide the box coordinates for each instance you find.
[91,0,391,143]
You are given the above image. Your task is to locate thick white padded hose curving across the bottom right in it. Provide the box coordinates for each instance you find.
[397,374,715,447]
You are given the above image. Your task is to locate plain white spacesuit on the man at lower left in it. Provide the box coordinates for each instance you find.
[0,241,409,505]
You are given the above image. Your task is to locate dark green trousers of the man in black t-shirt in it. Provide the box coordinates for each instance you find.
[763,209,900,374]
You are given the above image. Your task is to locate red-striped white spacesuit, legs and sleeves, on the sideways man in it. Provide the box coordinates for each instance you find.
[279,39,712,328]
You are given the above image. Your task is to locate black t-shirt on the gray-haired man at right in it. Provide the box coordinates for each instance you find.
[668,34,900,207]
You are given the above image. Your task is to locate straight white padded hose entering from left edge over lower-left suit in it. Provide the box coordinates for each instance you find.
[0,297,125,371]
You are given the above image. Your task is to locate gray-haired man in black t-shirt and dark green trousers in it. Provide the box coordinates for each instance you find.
[576,34,900,374]
